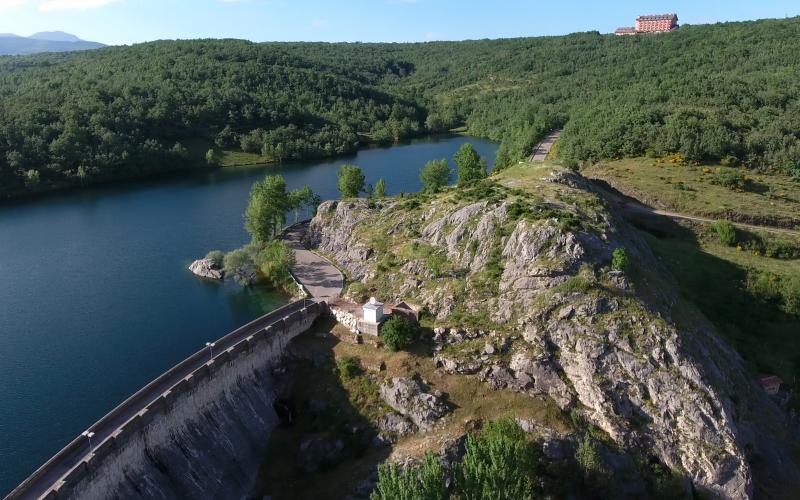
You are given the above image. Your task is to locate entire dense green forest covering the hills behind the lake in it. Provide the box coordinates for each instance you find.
[0,18,800,195]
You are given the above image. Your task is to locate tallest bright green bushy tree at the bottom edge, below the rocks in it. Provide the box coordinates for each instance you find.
[456,419,537,499]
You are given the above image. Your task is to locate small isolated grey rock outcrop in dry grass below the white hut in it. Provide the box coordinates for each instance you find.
[380,378,450,431]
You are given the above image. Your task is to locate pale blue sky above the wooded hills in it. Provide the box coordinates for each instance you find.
[0,0,800,44]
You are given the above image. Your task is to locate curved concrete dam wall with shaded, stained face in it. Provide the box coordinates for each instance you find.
[9,301,326,499]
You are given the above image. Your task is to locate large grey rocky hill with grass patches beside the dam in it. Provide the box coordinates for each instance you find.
[308,165,797,498]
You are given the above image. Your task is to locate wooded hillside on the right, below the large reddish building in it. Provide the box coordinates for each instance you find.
[280,18,800,176]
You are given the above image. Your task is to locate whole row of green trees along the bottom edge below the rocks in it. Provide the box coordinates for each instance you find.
[371,419,689,500]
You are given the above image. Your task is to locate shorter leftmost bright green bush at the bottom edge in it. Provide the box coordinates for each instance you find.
[370,452,450,500]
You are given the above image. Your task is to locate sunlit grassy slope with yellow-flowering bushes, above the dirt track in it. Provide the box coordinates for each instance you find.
[583,158,800,228]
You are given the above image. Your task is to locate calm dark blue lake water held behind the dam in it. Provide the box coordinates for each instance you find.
[0,137,497,496]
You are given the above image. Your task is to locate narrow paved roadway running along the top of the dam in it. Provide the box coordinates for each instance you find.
[7,300,308,500]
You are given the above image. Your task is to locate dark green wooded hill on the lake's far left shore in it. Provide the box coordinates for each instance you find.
[0,40,425,196]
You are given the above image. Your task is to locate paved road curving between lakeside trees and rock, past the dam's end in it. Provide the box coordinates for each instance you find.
[283,223,344,301]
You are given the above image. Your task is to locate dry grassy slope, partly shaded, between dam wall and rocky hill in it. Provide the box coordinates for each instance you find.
[256,316,571,500]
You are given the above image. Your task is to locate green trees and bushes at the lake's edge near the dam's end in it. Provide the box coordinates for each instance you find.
[216,175,320,290]
